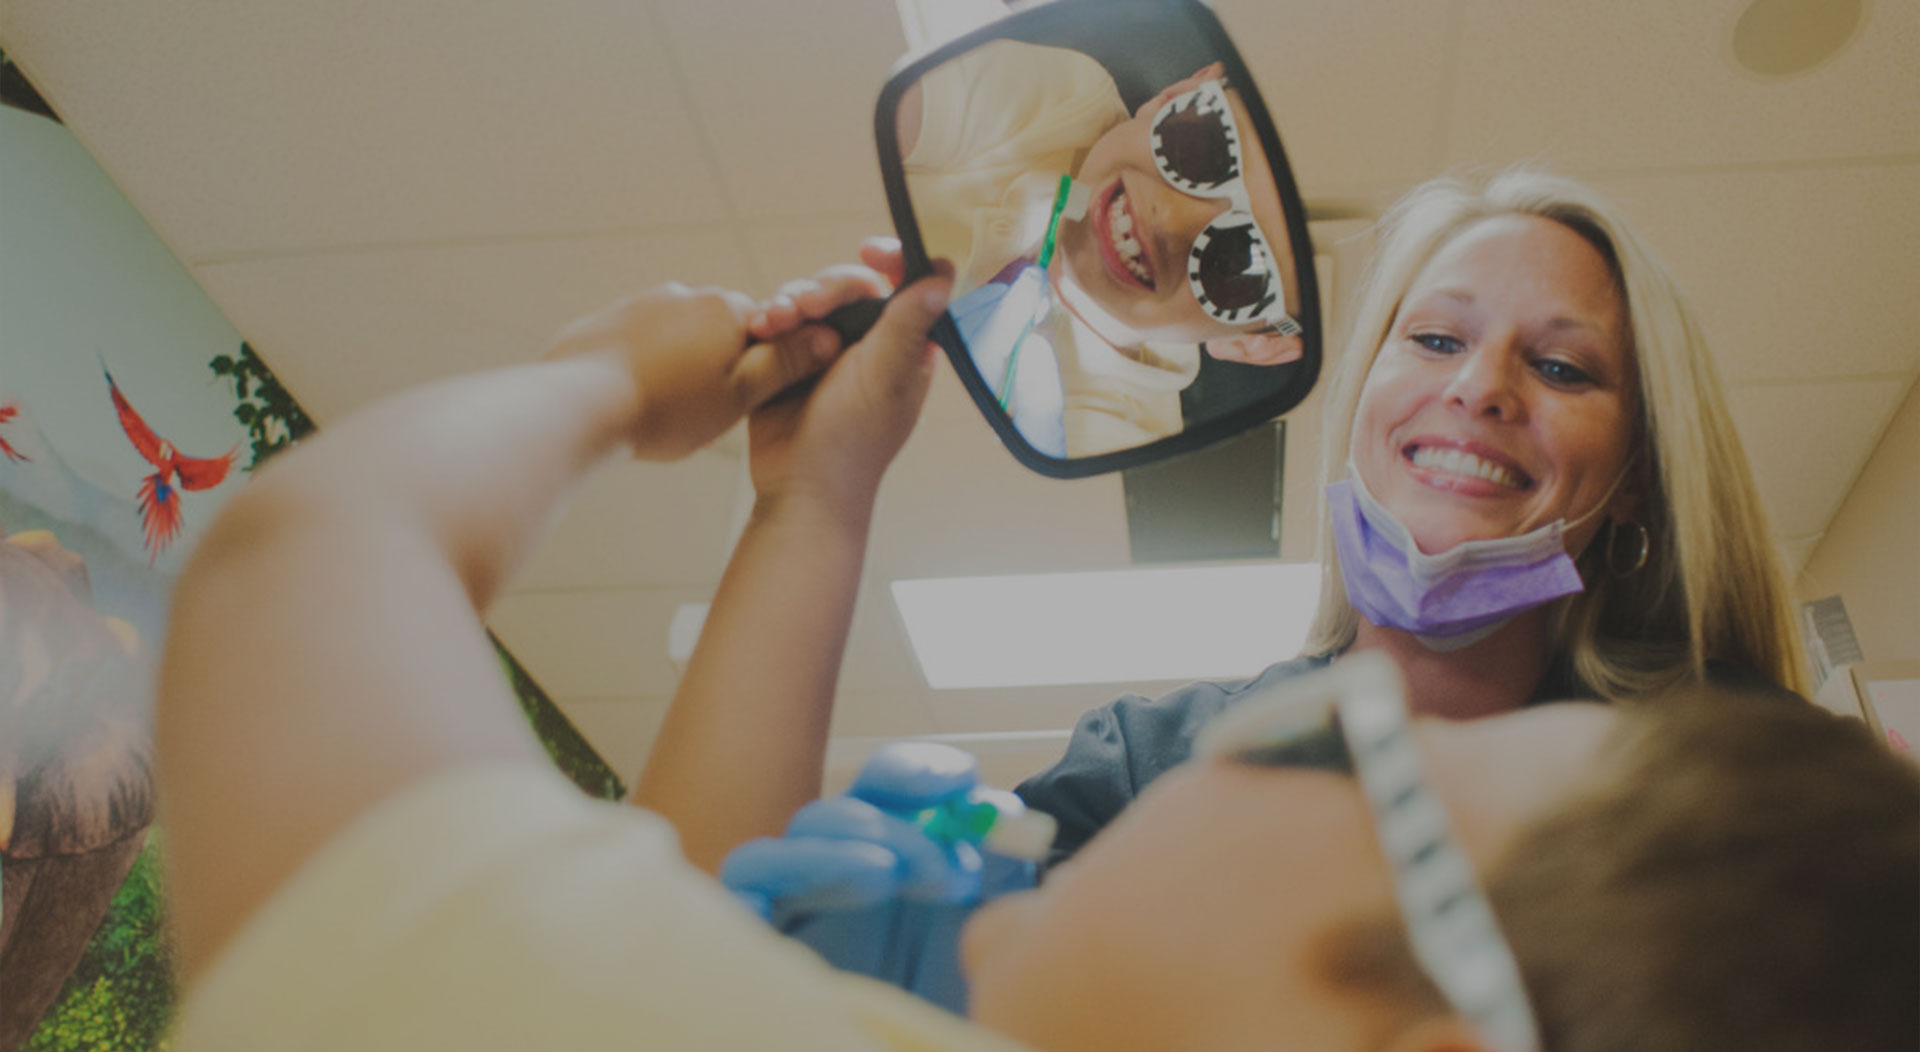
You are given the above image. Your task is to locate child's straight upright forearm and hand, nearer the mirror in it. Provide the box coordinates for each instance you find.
[634,242,948,872]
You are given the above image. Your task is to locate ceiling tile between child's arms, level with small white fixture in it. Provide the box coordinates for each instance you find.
[488,587,710,699]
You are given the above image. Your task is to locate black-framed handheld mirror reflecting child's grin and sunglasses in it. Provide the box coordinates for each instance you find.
[876,0,1321,478]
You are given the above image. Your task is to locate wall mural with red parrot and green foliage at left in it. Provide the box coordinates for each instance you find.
[0,54,622,1052]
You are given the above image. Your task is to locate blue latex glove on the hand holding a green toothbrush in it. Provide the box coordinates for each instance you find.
[720,743,1033,1012]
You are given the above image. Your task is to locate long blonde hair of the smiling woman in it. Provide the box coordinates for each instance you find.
[1306,169,1807,699]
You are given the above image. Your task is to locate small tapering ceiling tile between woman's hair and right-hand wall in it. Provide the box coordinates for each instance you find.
[1728,376,1912,538]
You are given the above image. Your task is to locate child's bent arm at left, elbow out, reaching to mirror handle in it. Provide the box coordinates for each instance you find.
[156,272,944,977]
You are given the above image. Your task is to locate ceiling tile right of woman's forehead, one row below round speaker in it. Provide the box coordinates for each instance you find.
[1599,168,1920,382]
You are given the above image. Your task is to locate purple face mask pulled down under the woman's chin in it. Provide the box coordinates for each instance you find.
[1327,466,1582,651]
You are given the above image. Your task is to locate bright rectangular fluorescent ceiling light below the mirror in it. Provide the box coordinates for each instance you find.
[893,562,1321,689]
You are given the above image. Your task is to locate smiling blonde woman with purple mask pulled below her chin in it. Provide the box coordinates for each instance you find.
[1020,169,1805,858]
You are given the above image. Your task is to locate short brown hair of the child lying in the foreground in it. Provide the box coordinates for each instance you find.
[1327,691,1920,1052]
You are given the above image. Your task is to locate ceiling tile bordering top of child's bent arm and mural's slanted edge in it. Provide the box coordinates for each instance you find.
[194,230,749,420]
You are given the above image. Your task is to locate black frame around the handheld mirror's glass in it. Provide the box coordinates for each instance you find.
[874,0,1323,478]
